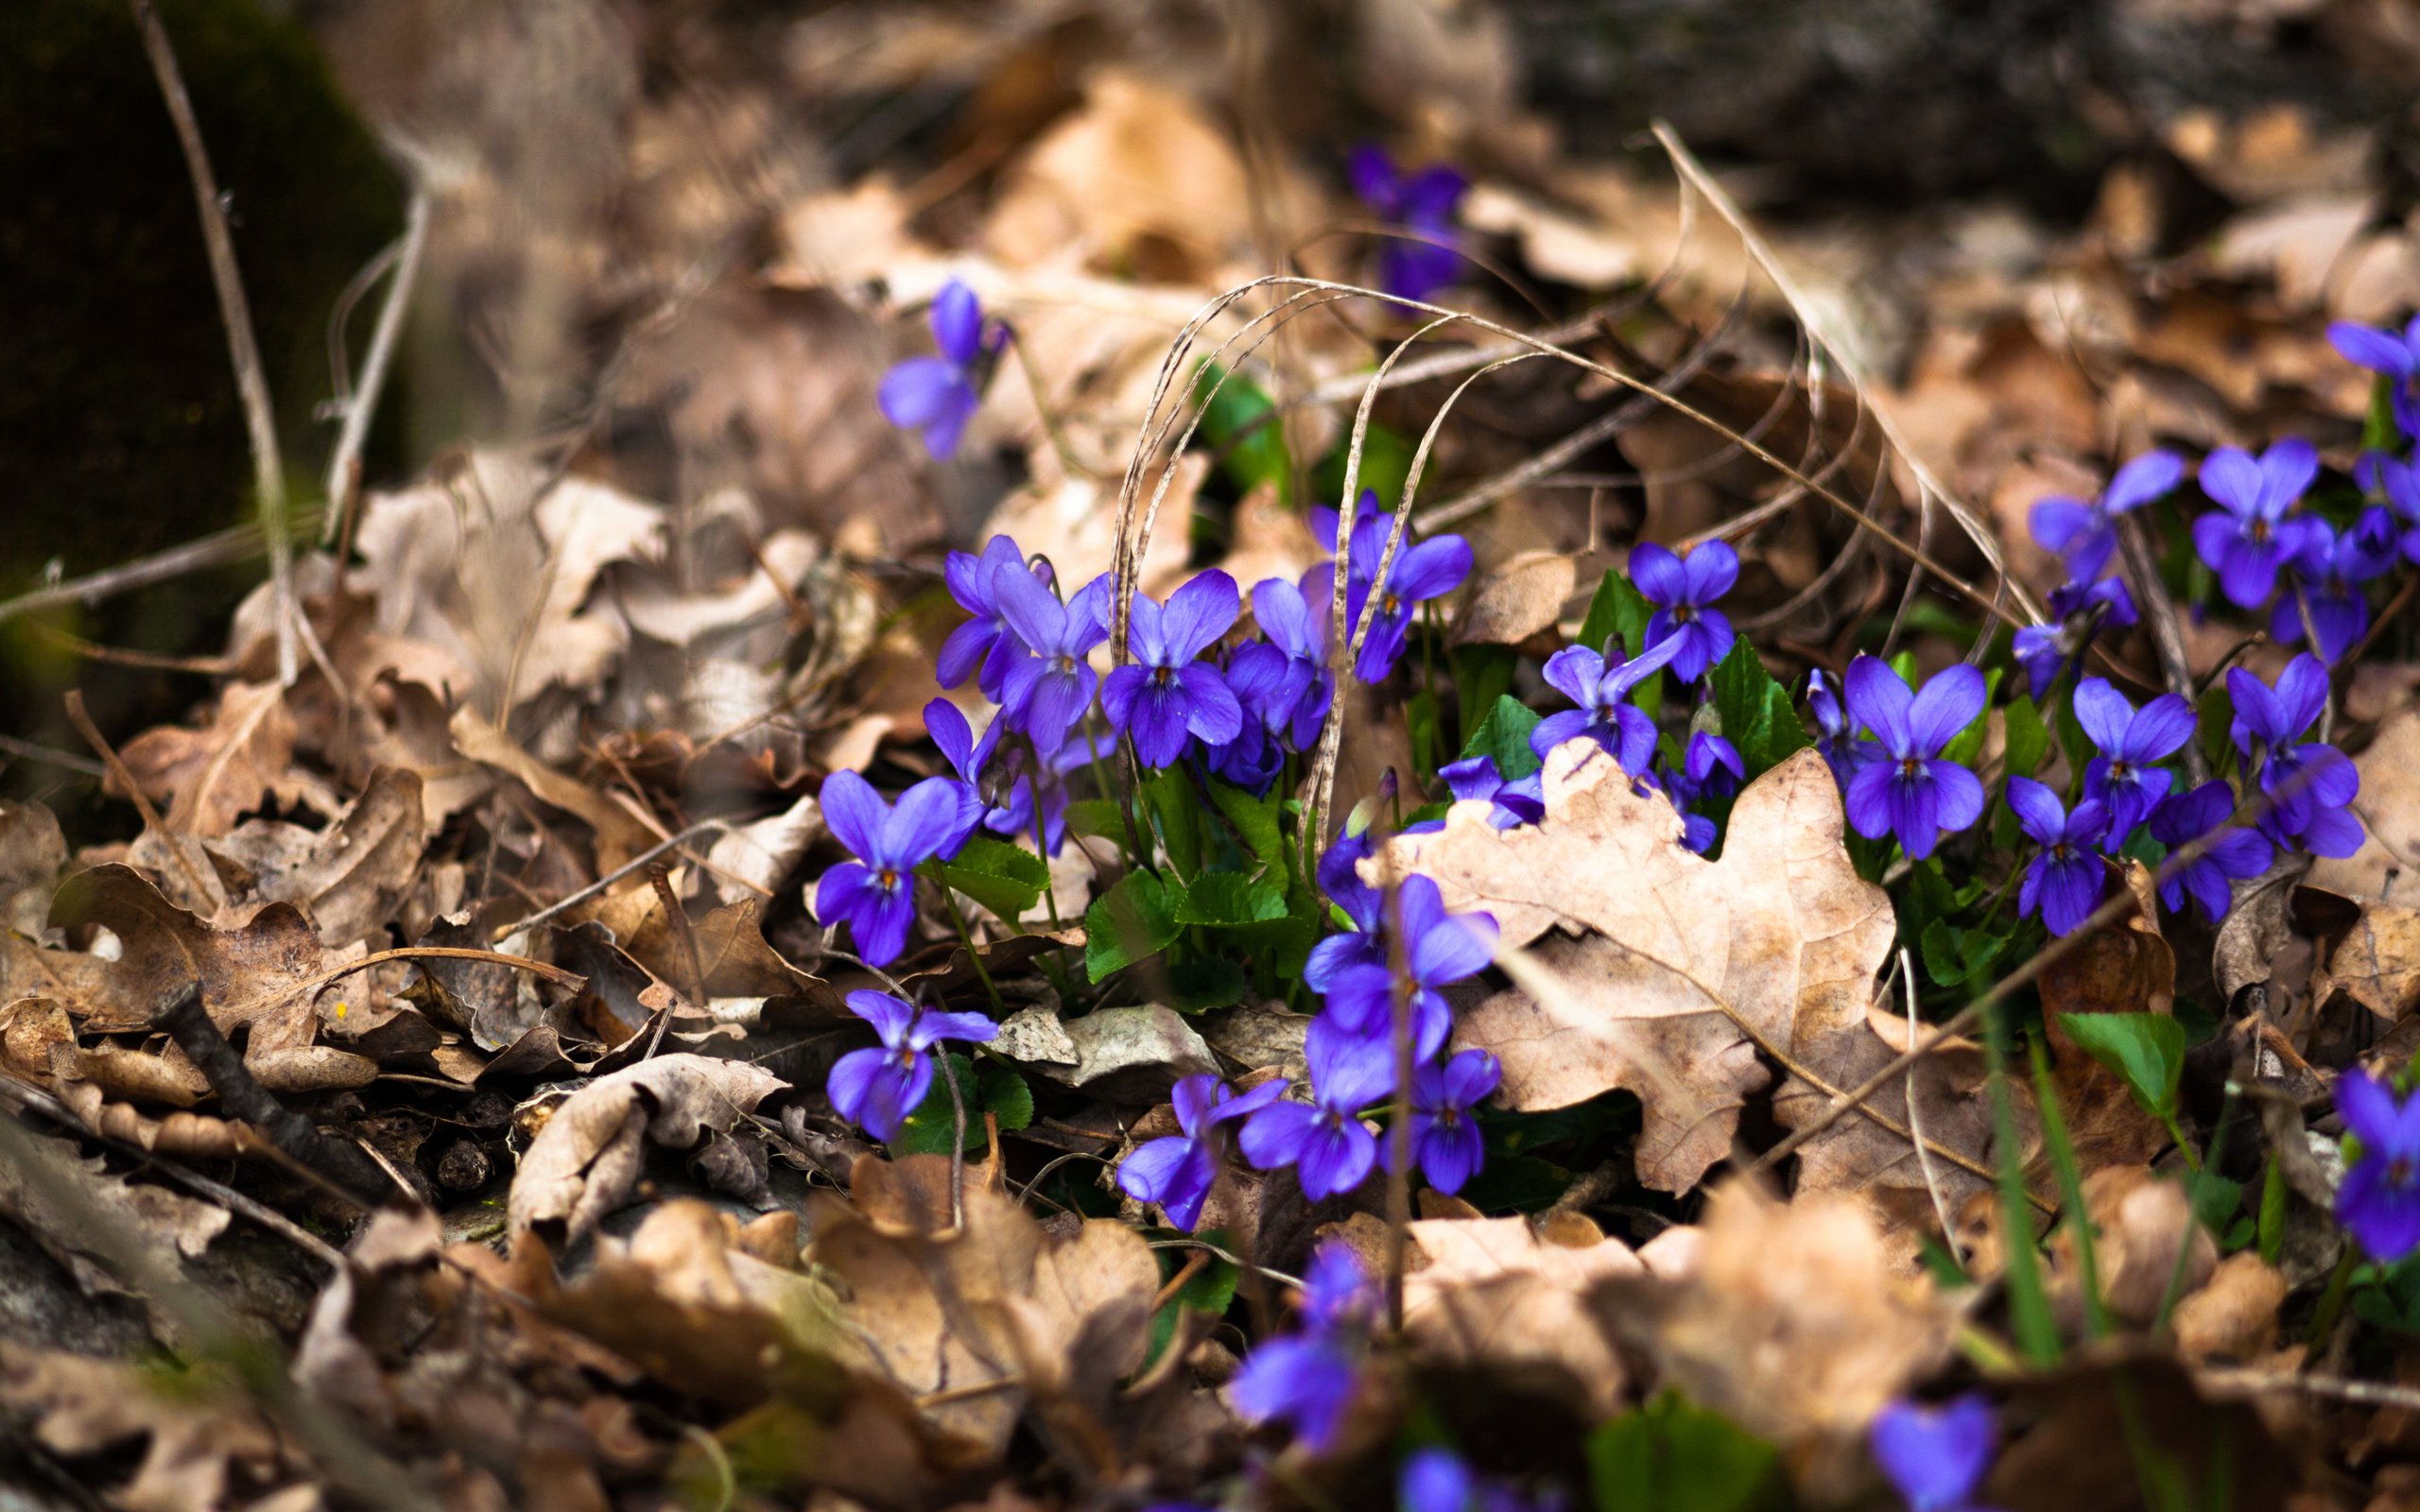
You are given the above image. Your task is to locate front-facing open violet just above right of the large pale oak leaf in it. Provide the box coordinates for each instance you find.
[1849,656,1984,861]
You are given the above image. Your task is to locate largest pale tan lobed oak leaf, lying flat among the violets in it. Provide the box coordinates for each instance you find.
[1393,740,1922,1193]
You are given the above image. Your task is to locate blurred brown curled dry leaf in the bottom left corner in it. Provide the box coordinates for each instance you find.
[0,1343,285,1512]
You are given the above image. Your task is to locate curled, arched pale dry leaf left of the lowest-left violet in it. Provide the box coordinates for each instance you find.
[506,1055,789,1241]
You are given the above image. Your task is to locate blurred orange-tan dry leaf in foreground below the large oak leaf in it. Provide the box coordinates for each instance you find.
[1598,1180,1958,1500]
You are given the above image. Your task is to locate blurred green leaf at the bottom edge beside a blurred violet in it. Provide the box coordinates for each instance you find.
[1587,1391,1793,1512]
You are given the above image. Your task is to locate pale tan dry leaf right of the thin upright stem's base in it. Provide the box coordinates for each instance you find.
[1404,1217,1646,1418]
